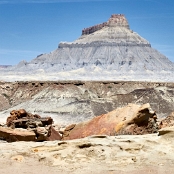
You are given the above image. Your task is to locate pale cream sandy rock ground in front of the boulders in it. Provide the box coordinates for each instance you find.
[0,134,174,174]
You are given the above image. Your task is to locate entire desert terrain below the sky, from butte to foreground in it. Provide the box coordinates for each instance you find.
[0,14,174,174]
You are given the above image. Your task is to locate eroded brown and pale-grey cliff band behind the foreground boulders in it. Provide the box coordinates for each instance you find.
[0,81,174,125]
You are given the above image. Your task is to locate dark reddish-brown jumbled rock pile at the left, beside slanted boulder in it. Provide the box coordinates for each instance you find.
[0,109,61,142]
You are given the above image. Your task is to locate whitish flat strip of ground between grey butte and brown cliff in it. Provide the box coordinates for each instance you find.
[0,70,173,82]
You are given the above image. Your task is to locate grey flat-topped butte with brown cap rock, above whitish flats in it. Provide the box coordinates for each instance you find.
[23,14,174,71]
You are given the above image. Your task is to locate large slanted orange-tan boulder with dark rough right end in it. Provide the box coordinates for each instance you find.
[63,104,158,140]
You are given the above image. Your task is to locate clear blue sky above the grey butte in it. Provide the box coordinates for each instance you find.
[0,0,174,65]
